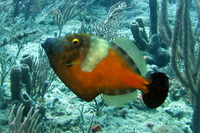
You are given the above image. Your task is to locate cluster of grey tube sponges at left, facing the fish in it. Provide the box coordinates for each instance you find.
[10,51,52,117]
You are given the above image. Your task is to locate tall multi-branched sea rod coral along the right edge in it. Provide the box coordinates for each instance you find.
[156,0,200,133]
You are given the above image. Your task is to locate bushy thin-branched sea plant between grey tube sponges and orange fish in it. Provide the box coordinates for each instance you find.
[20,47,56,100]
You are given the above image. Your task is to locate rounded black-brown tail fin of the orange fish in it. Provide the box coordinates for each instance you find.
[142,72,169,109]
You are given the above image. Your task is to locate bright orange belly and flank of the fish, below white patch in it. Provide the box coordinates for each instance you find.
[52,49,148,101]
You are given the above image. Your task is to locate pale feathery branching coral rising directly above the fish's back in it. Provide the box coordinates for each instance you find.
[78,2,127,41]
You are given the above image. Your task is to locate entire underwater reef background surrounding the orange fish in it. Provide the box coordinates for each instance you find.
[0,0,200,133]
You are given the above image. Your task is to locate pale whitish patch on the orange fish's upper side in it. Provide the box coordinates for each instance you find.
[81,36,111,72]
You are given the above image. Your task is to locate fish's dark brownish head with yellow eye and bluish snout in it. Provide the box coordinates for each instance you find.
[42,34,91,68]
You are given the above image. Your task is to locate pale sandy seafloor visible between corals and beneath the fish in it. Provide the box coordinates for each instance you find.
[0,0,195,133]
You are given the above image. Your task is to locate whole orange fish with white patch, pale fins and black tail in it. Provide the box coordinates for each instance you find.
[41,33,169,108]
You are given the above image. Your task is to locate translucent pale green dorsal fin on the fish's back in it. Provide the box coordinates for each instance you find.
[113,37,147,76]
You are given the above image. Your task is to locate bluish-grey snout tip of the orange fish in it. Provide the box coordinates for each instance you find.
[42,38,56,55]
